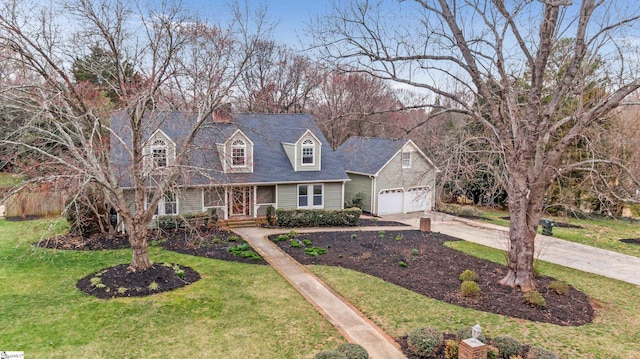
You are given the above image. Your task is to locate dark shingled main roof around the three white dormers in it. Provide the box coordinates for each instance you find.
[111,112,348,187]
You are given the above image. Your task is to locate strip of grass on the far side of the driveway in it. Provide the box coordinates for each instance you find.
[470,209,640,257]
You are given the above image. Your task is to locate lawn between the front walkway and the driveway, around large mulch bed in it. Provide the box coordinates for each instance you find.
[310,241,640,358]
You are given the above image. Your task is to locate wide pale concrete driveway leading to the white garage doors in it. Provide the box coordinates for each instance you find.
[385,212,640,286]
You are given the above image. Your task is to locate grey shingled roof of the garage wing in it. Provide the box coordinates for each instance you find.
[336,137,408,175]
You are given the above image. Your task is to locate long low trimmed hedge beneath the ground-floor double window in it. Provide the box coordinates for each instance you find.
[276,208,362,227]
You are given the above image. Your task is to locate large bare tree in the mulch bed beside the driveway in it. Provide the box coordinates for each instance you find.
[314,0,640,291]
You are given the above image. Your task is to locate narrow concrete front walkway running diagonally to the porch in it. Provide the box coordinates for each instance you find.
[234,227,407,359]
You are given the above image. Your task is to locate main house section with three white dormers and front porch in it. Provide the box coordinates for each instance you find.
[111,112,349,219]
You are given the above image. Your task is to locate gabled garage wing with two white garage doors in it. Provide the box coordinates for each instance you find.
[336,137,440,216]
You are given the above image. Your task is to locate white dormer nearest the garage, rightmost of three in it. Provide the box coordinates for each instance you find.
[282,130,322,172]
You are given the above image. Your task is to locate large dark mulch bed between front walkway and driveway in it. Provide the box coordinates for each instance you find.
[278,231,594,326]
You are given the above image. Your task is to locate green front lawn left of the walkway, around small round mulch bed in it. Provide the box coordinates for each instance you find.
[0,220,344,358]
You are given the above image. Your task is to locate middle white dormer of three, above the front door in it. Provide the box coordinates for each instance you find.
[218,130,253,173]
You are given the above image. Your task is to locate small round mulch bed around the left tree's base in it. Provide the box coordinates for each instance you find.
[76,263,200,299]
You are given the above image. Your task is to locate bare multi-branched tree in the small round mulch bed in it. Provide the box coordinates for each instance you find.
[0,0,263,271]
